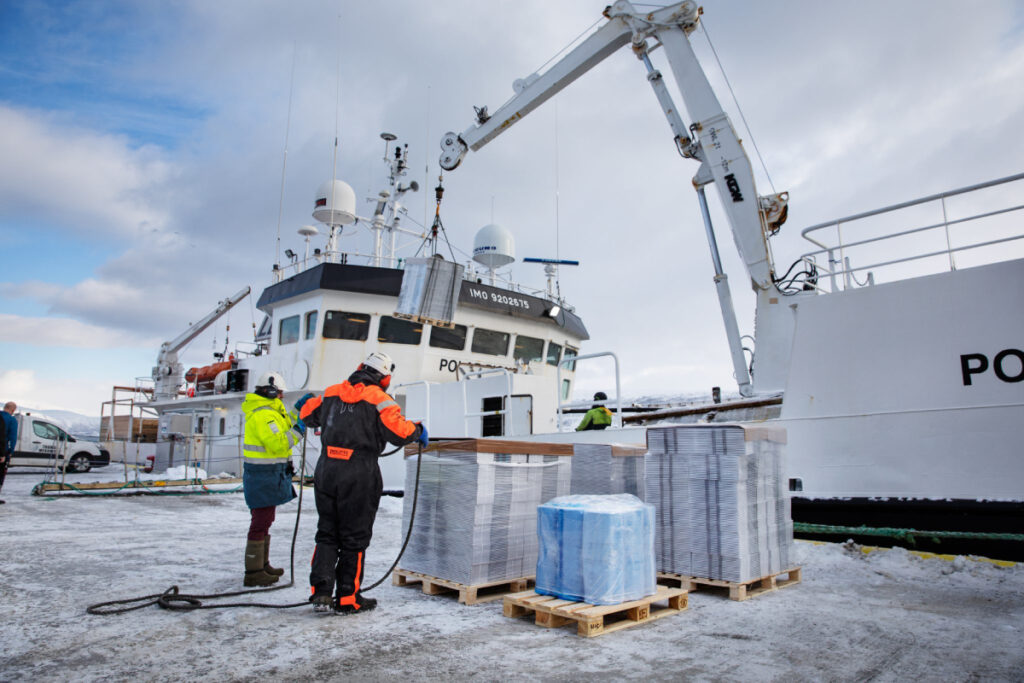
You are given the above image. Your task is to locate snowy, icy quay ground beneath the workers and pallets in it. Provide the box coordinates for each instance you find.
[0,470,1024,681]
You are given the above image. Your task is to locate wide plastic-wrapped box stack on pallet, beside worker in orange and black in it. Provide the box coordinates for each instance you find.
[400,439,572,586]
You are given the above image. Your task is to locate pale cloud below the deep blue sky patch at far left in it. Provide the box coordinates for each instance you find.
[0,104,173,236]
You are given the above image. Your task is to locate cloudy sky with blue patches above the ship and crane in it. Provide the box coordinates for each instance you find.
[0,0,1024,415]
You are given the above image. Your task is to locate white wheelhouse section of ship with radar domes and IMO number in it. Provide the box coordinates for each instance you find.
[103,133,588,488]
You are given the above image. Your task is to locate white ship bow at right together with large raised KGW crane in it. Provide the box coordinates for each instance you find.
[417,0,1024,558]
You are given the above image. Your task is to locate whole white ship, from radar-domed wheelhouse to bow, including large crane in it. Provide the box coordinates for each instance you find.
[97,0,1024,557]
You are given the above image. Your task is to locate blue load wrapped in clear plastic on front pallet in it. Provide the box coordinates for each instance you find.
[536,494,657,605]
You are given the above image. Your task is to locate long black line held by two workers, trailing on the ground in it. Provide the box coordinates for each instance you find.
[86,434,423,615]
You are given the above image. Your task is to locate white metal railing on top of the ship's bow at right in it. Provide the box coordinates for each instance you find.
[791,173,1024,292]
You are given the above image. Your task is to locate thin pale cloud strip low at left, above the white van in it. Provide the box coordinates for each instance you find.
[0,313,160,349]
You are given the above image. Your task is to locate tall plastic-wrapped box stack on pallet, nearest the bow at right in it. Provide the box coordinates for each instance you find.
[645,425,793,583]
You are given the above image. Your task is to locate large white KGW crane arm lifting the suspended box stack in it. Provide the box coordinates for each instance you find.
[440,0,793,396]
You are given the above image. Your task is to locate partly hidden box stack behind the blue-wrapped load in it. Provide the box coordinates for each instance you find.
[570,443,645,500]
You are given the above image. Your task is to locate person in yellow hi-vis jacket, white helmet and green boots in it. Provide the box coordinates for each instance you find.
[242,373,299,586]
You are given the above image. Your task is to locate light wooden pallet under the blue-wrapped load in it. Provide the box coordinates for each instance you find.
[503,586,687,638]
